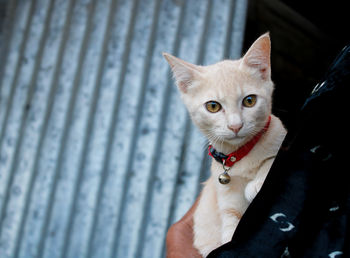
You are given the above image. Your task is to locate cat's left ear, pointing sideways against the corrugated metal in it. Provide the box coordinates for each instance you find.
[163,52,203,93]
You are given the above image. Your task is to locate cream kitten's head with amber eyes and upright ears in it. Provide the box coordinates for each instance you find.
[163,33,273,148]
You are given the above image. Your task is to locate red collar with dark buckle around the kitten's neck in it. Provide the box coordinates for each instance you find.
[208,116,271,167]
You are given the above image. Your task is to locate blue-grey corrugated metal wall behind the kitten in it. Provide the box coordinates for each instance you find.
[0,0,247,258]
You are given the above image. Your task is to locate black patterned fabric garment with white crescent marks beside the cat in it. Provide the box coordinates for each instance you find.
[208,43,350,258]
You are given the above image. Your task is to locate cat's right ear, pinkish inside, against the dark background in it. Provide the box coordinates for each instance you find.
[241,33,271,80]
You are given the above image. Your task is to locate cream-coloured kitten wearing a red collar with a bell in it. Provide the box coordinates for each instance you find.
[163,33,287,257]
